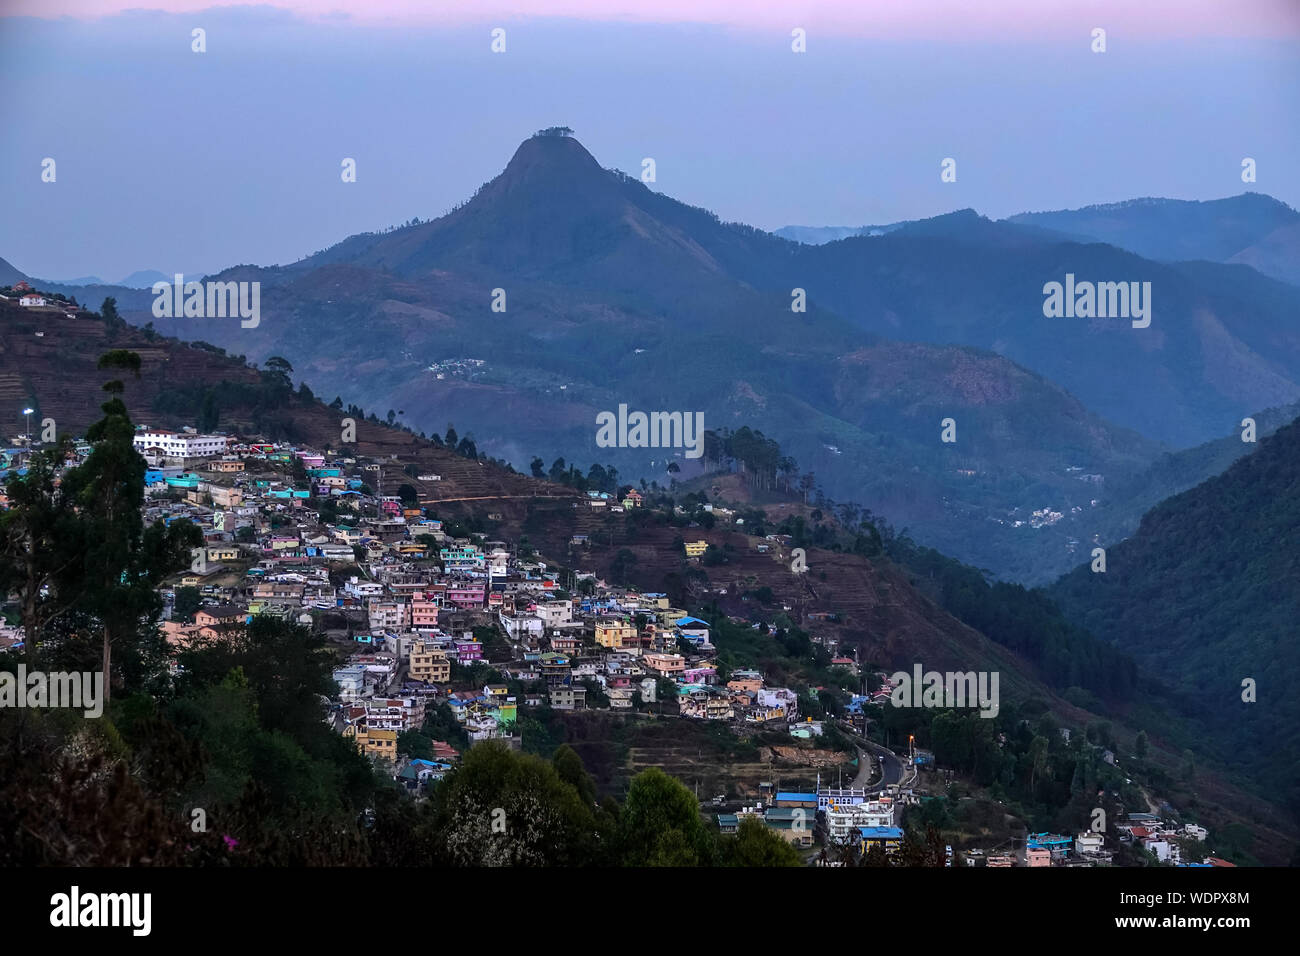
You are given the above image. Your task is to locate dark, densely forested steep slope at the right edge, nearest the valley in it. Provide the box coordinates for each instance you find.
[1050,420,1300,812]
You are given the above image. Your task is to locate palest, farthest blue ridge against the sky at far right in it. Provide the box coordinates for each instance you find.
[1008,193,1300,282]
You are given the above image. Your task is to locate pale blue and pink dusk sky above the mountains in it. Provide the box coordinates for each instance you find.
[0,0,1300,281]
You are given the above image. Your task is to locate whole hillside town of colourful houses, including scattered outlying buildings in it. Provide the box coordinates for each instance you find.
[0,425,1231,868]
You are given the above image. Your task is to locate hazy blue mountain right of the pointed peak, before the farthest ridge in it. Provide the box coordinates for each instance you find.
[795,213,1300,447]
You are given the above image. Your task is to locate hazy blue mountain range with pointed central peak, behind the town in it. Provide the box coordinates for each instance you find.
[10,135,1300,581]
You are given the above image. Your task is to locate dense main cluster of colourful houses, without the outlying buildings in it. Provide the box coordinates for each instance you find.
[45,425,820,786]
